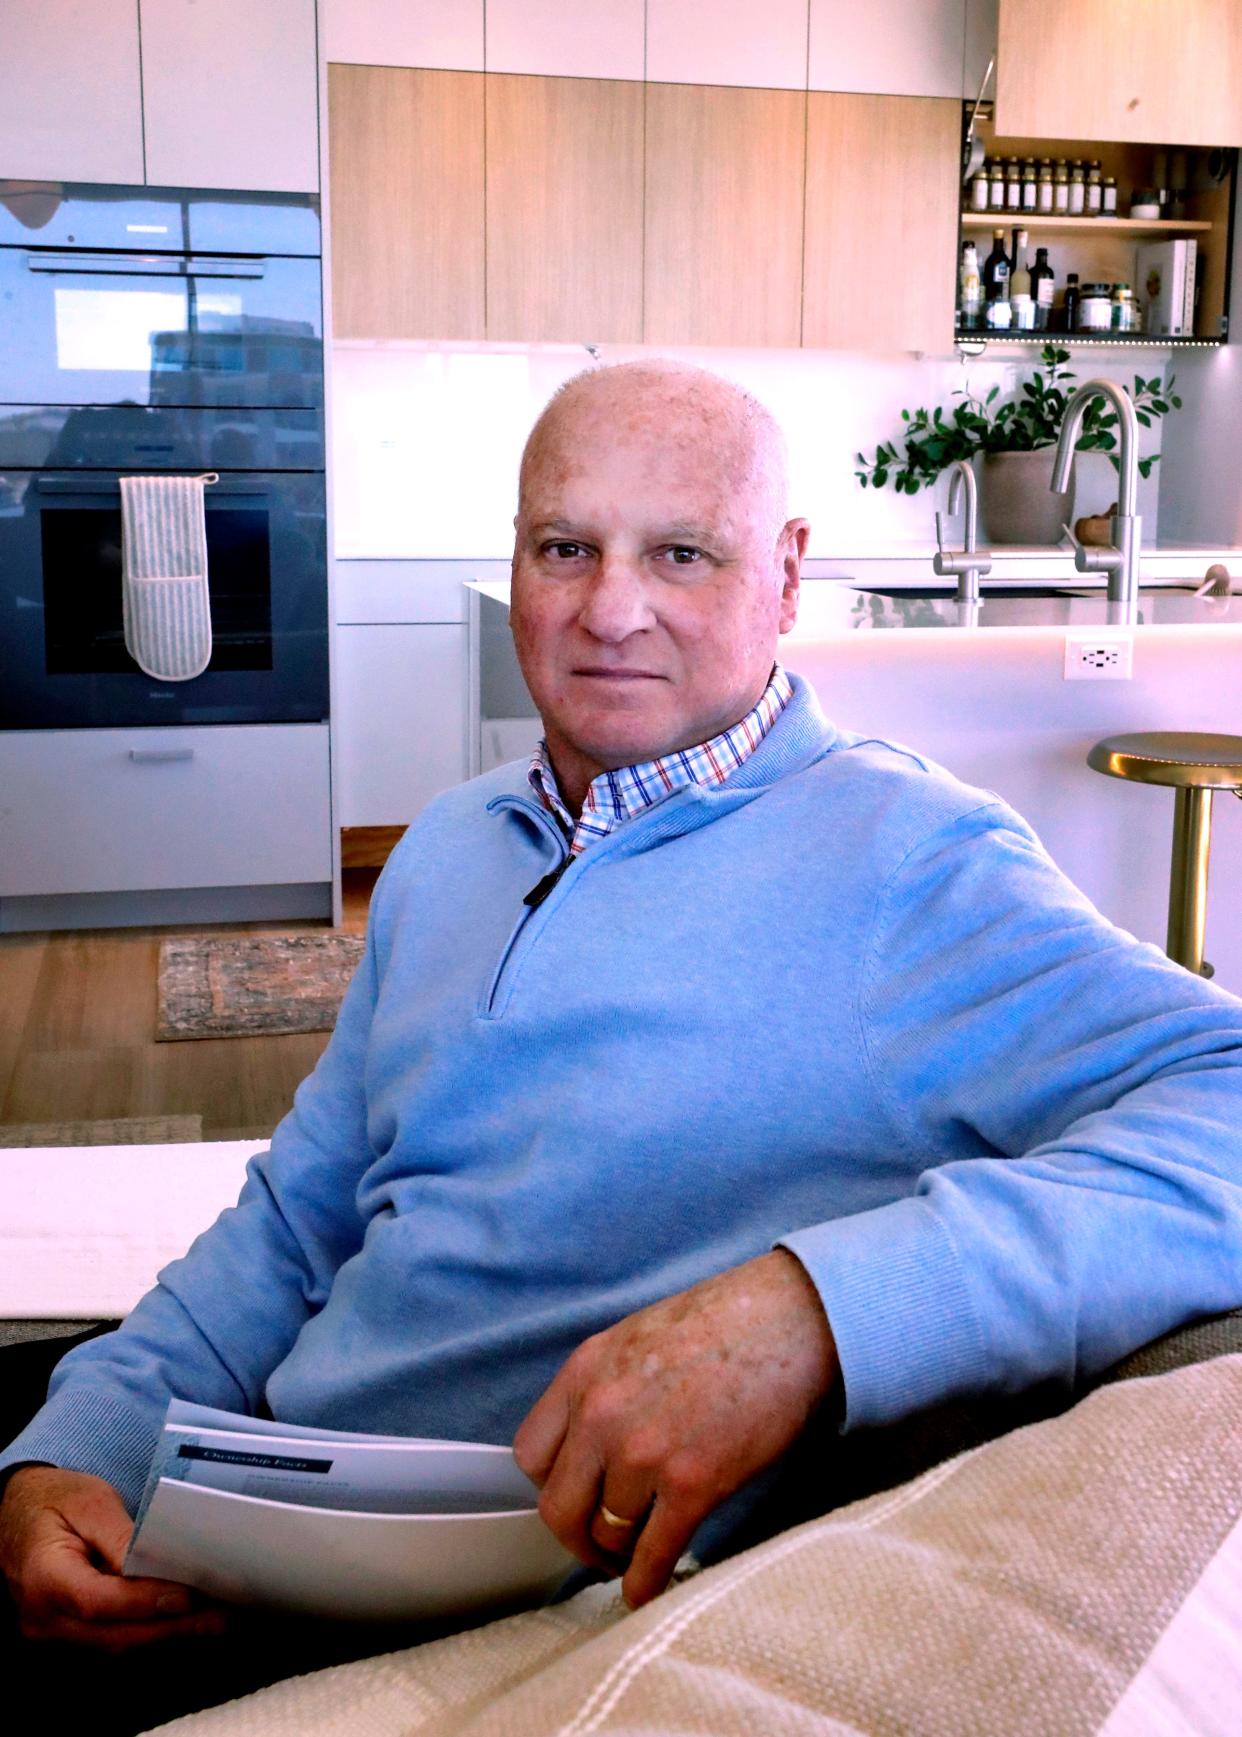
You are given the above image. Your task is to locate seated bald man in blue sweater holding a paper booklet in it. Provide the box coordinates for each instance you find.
[0,363,1242,1716]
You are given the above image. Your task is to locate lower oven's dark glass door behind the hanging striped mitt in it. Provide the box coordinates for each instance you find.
[0,471,328,730]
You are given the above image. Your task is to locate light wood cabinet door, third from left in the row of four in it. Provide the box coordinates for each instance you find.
[643,85,805,346]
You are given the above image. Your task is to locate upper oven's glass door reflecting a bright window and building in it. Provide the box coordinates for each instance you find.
[0,247,323,408]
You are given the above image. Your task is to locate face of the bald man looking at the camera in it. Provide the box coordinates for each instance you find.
[511,383,808,802]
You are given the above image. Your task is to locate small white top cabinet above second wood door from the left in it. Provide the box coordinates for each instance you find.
[483,0,650,82]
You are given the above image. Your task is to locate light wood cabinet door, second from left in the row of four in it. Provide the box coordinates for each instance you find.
[486,73,643,344]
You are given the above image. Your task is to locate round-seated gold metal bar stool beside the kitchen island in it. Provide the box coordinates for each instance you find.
[1087,730,1242,976]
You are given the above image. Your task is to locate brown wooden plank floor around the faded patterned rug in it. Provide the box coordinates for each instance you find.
[0,869,379,1139]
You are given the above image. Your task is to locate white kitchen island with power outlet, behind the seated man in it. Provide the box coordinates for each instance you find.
[471,569,1242,994]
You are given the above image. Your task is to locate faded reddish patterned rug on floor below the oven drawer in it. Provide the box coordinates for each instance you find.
[155,931,365,1042]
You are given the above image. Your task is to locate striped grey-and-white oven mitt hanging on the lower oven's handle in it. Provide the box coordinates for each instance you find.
[120,471,219,681]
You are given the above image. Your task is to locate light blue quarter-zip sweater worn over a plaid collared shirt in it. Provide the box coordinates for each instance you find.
[0,677,1242,1549]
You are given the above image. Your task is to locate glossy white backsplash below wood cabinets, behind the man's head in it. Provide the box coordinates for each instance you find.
[332,340,1169,559]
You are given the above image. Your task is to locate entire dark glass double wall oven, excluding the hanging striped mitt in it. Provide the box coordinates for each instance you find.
[0,182,328,730]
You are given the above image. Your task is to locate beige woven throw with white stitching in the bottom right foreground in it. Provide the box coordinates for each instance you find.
[148,1355,1242,1737]
